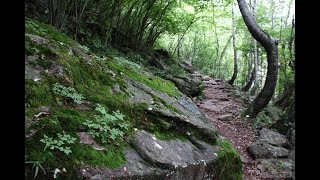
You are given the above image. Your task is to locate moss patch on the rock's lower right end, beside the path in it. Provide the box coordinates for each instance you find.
[216,140,242,180]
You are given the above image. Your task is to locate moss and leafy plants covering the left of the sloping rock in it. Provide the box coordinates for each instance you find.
[25,18,182,179]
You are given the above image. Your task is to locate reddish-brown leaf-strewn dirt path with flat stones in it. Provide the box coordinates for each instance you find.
[196,77,261,180]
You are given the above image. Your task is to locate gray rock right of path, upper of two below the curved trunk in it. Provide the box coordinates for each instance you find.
[259,128,288,146]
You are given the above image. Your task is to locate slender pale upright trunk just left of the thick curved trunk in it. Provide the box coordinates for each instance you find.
[228,4,238,85]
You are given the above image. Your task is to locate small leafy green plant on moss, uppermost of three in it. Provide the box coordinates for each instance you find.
[53,83,84,104]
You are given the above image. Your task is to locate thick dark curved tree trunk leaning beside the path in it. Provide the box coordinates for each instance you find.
[237,0,278,118]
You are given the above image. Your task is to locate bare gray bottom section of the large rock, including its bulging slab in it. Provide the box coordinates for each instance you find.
[77,130,241,180]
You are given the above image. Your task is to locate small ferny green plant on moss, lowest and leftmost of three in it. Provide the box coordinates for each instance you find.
[40,133,77,155]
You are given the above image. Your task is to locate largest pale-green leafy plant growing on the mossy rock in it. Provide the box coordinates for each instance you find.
[83,104,129,143]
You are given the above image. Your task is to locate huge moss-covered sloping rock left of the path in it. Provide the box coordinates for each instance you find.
[25,18,242,179]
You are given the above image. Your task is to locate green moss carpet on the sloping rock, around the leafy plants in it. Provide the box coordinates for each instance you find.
[25,18,241,179]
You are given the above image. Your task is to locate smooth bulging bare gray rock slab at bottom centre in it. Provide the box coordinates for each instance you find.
[132,131,218,170]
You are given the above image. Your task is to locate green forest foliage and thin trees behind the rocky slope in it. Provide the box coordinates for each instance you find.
[25,0,295,119]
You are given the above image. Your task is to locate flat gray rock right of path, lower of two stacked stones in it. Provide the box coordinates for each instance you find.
[247,141,289,159]
